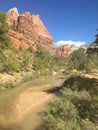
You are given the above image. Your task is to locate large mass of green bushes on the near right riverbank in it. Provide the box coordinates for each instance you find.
[43,75,98,130]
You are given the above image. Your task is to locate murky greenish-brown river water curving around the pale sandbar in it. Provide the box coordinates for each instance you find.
[0,77,64,130]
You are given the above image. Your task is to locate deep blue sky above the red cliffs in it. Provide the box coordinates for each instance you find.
[0,0,98,44]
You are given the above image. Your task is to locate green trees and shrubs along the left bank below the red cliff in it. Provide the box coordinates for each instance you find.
[0,12,65,89]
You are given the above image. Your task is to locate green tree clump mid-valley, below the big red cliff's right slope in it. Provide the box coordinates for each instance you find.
[33,47,64,71]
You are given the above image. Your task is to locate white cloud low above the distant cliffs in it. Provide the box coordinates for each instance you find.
[55,40,86,47]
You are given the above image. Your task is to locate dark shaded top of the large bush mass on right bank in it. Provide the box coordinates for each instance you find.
[63,74,98,96]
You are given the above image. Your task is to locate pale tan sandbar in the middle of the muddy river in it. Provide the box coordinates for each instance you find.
[15,85,53,120]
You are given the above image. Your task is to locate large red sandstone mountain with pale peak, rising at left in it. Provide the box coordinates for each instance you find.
[7,8,56,54]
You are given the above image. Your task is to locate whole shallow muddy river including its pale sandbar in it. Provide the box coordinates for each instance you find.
[0,76,64,130]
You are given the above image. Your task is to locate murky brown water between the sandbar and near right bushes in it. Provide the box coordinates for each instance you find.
[12,104,46,130]
